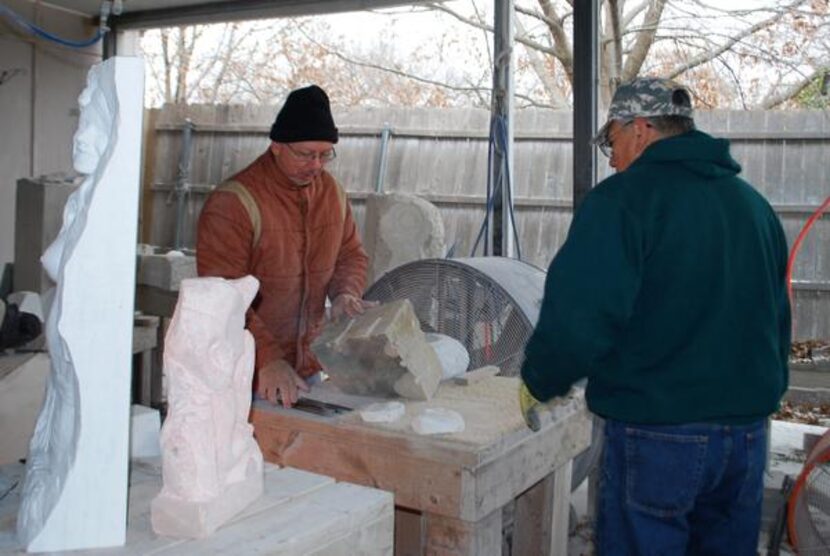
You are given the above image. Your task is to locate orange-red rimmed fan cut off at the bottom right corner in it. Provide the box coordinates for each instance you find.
[787,431,830,554]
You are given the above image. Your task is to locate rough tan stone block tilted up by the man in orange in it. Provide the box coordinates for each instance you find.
[311,299,442,400]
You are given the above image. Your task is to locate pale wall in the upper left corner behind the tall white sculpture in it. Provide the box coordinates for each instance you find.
[0,0,101,282]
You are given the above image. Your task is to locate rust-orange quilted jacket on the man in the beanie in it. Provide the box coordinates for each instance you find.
[196,151,368,377]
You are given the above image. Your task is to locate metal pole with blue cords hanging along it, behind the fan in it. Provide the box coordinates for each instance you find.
[487,0,515,257]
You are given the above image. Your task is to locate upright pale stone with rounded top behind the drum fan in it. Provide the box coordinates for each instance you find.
[363,193,446,284]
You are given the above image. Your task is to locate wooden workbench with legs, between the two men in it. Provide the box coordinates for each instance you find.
[252,377,591,556]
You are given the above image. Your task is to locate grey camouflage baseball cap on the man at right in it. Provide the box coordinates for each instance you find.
[591,77,693,144]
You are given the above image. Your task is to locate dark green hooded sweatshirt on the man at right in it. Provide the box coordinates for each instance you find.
[522,131,790,425]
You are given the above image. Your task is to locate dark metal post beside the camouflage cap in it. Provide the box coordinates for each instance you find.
[573,0,599,213]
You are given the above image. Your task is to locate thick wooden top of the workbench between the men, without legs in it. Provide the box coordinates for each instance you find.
[252,377,591,521]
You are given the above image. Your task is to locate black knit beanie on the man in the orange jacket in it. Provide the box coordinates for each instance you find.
[268,85,337,143]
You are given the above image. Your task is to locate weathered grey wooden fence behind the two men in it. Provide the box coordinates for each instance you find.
[141,106,830,339]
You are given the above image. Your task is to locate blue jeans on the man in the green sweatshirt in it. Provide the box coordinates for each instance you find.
[595,420,767,556]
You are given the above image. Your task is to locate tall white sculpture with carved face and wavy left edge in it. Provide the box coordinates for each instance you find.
[17,57,144,552]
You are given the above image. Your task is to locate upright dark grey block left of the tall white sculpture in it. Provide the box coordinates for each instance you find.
[13,174,81,293]
